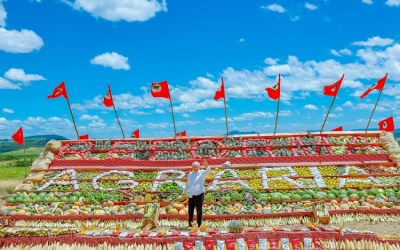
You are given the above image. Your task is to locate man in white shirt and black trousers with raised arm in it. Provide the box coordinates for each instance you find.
[183,159,211,227]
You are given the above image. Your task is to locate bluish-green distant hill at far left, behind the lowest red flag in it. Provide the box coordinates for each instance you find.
[0,135,67,153]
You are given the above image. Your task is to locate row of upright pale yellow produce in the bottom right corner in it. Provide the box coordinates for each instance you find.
[322,240,400,250]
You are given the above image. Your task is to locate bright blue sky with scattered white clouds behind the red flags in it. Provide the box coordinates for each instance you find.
[0,0,400,138]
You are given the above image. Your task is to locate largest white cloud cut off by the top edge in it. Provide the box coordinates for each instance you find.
[64,0,167,22]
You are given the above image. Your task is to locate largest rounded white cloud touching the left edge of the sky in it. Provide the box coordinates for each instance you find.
[0,28,43,53]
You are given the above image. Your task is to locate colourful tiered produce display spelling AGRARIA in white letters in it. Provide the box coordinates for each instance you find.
[0,132,400,249]
